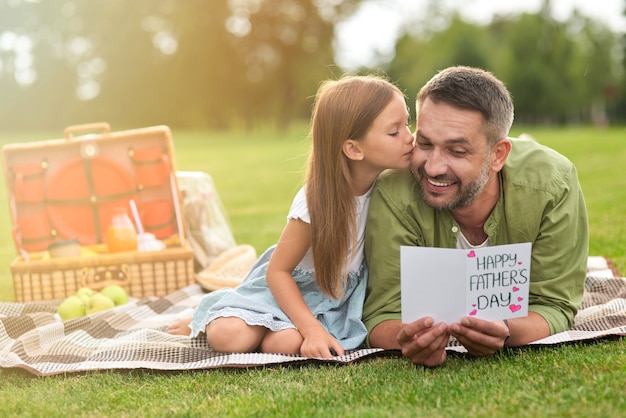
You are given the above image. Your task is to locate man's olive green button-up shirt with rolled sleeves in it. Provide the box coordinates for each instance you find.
[363,139,589,342]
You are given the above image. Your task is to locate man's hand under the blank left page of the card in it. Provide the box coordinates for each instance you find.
[397,317,449,367]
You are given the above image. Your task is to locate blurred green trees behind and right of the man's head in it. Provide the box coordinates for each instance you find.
[388,11,626,125]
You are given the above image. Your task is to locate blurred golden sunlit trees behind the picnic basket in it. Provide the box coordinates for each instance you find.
[0,0,360,128]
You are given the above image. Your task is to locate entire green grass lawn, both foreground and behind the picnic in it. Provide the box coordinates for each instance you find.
[0,125,626,417]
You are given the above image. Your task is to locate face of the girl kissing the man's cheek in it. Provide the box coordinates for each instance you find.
[362,93,414,170]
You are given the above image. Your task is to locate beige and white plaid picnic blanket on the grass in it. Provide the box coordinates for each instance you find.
[0,257,626,376]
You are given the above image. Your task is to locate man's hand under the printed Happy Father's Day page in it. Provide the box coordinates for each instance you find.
[447,317,509,357]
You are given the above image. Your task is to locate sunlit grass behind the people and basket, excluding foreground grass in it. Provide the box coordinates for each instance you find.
[0,124,626,300]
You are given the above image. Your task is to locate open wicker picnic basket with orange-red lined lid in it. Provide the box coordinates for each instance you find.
[2,123,195,302]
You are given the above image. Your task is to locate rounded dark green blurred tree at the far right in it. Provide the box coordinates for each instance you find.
[501,10,619,123]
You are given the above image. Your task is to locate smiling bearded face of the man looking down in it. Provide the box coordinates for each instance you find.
[411,99,493,210]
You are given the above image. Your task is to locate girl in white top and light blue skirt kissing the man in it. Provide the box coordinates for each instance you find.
[168,76,413,358]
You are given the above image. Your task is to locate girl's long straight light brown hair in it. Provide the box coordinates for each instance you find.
[306,75,402,298]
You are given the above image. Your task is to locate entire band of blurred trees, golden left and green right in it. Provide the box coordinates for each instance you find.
[0,0,626,130]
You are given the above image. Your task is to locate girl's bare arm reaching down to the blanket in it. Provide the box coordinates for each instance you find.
[267,219,344,357]
